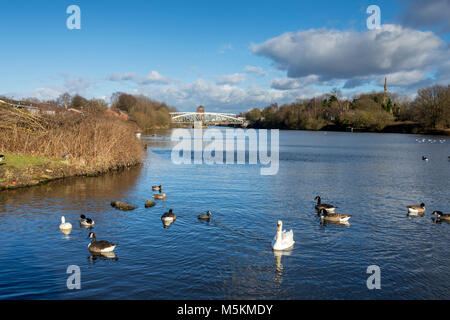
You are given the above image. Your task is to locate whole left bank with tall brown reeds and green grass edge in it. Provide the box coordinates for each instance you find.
[0,106,143,190]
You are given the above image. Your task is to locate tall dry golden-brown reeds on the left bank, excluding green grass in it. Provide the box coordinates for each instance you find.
[0,106,143,173]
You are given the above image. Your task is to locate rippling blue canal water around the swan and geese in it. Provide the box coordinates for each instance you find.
[0,131,450,299]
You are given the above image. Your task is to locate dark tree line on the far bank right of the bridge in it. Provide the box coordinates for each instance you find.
[244,85,450,131]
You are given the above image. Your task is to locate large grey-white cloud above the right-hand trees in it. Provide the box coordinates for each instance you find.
[252,25,449,87]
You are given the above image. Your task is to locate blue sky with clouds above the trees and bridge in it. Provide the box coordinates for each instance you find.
[0,0,450,112]
